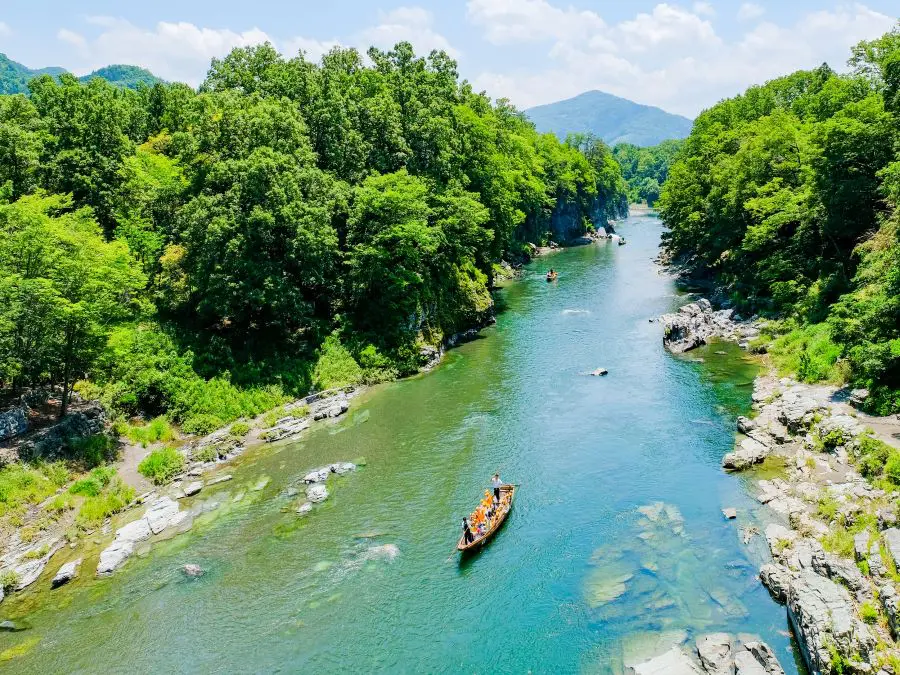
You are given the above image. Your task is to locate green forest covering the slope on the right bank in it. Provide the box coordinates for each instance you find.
[660,28,900,414]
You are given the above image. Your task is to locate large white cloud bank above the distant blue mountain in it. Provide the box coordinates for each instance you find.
[469,0,894,116]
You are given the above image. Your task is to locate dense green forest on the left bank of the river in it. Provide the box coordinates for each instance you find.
[0,43,626,432]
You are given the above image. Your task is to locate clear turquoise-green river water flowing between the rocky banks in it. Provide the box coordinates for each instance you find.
[0,217,796,673]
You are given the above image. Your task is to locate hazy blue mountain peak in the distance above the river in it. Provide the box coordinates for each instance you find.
[525,91,693,147]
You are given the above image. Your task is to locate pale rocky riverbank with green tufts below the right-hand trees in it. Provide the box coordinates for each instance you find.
[660,299,900,674]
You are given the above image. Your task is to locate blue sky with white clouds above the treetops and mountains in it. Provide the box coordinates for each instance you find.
[0,0,900,117]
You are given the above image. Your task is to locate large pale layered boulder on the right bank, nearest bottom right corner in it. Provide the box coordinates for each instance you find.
[787,570,875,672]
